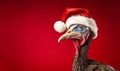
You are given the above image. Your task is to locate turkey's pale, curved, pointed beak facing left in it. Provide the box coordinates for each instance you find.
[58,30,80,42]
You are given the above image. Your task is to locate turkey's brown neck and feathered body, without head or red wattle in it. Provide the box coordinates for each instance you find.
[72,32,117,71]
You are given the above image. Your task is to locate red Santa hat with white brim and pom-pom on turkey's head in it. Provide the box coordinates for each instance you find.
[54,8,98,38]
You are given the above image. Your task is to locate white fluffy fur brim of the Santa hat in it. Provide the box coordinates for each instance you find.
[66,15,98,39]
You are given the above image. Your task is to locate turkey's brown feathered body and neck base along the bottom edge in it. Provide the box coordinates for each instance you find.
[72,57,117,71]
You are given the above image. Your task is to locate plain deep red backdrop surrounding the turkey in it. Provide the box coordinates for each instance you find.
[0,0,120,71]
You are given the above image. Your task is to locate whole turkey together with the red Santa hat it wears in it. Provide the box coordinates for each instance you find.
[54,8,117,71]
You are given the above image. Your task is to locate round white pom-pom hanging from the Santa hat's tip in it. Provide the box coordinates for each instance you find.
[54,21,66,33]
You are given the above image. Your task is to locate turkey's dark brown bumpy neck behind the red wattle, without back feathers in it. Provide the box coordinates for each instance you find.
[73,32,93,71]
